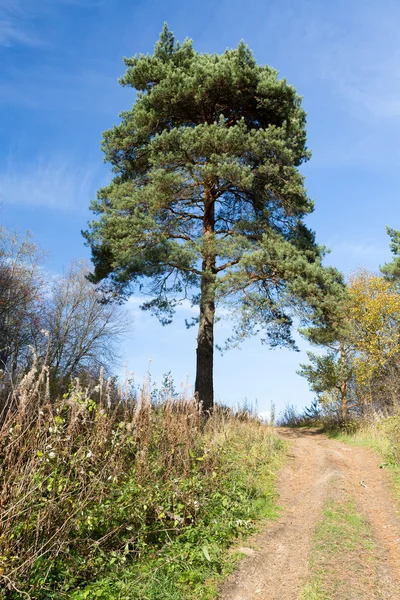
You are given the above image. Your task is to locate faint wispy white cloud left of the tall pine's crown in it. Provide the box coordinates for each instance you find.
[0,158,104,211]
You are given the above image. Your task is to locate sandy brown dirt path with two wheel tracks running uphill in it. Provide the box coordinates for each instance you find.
[220,430,400,600]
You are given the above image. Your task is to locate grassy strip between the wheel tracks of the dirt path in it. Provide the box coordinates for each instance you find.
[299,499,377,600]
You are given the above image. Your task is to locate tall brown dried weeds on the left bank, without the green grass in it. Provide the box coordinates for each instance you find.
[0,356,202,593]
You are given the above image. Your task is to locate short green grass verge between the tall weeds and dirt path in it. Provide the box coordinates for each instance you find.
[70,422,282,600]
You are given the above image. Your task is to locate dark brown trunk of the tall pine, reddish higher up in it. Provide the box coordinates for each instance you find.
[195,189,216,412]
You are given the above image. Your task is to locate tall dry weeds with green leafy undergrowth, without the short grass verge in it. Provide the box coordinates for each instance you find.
[0,364,273,599]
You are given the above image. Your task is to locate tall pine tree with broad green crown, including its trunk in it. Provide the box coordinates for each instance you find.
[84,25,341,410]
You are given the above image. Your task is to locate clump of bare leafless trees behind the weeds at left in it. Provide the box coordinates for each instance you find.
[0,226,131,403]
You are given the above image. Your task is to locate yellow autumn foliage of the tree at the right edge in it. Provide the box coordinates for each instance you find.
[348,270,400,384]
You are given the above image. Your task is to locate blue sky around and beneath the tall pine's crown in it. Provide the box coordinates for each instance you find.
[0,0,400,410]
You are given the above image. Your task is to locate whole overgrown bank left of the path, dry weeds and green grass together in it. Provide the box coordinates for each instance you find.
[0,360,284,600]
